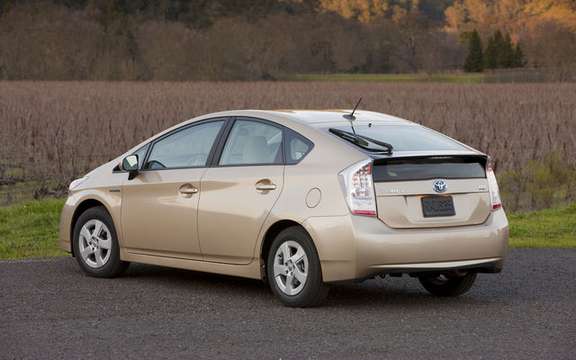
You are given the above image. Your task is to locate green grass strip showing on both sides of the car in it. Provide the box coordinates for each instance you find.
[0,199,576,259]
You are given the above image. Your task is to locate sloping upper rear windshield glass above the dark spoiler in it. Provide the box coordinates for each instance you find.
[333,125,468,152]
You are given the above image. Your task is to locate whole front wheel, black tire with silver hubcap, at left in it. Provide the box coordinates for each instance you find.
[72,206,129,278]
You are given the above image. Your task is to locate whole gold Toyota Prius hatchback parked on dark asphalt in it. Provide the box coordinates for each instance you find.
[60,110,508,307]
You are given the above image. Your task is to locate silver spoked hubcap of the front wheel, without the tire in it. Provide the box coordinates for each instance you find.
[78,219,112,269]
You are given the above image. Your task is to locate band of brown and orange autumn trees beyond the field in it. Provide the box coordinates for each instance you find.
[0,0,576,80]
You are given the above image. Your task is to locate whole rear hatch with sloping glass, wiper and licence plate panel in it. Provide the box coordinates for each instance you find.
[329,121,491,229]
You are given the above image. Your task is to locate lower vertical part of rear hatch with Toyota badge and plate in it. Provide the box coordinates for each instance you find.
[373,155,491,229]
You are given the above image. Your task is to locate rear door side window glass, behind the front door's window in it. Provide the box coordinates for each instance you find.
[220,120,282,165]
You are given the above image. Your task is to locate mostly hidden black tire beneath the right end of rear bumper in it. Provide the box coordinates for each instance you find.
[419,272,477,297]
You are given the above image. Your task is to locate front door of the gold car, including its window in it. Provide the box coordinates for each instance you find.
[122,119,225,259]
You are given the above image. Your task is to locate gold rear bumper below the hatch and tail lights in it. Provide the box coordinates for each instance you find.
[304,210,508,282]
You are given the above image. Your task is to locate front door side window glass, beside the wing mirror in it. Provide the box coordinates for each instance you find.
[144,120,224,170]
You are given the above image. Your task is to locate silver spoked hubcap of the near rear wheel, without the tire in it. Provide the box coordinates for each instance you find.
[274,241,308,295]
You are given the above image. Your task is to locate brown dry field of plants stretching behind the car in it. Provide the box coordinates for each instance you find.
[0,82,576,209]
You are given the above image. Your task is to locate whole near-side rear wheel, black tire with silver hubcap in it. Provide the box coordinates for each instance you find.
[266,227,329,307]
